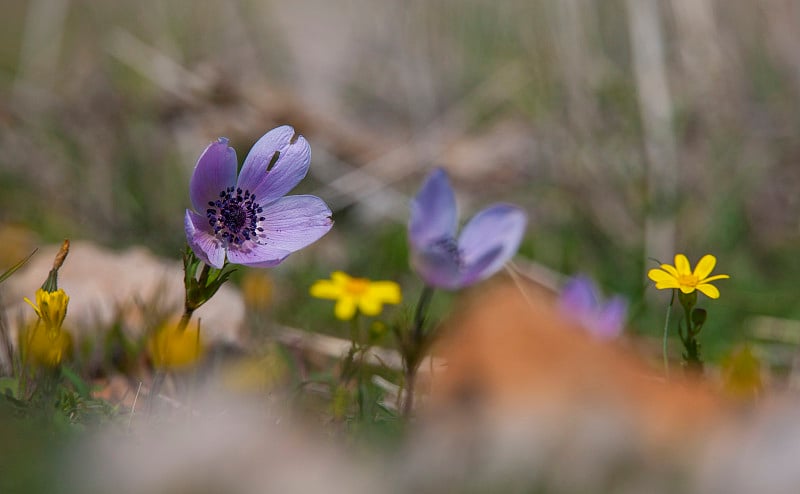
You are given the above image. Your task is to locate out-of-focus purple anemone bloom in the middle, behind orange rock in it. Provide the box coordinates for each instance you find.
[408,168,527,290]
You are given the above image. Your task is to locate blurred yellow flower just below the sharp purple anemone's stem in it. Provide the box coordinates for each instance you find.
[147,319,204,370]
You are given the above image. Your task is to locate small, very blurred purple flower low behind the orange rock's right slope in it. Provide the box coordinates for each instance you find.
[559,275,628,340]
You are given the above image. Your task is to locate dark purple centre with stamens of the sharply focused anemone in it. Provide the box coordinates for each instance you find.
[206,187,264,245]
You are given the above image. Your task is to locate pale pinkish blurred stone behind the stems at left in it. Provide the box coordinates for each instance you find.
[0,241,244,343]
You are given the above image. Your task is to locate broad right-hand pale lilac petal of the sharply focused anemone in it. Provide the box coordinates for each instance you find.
[259,196,333,252]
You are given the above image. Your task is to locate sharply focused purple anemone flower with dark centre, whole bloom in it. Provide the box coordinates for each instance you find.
[184,125,333,269]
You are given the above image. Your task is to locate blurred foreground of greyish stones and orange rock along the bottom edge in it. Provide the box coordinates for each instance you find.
[4,280,800,494]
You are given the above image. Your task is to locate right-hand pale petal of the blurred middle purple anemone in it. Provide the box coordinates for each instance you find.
[458,204,527,281]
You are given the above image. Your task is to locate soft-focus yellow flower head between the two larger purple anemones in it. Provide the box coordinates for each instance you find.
[310,271,402,321]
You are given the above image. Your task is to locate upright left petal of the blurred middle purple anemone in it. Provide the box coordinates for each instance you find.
[408,168,458,248]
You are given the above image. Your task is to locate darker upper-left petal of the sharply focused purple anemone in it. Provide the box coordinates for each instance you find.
[189,137,236,212]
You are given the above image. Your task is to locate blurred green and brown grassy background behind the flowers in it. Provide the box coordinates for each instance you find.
[0,0,800,360]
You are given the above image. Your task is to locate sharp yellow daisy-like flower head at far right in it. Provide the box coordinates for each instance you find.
[647,254,730,298]
